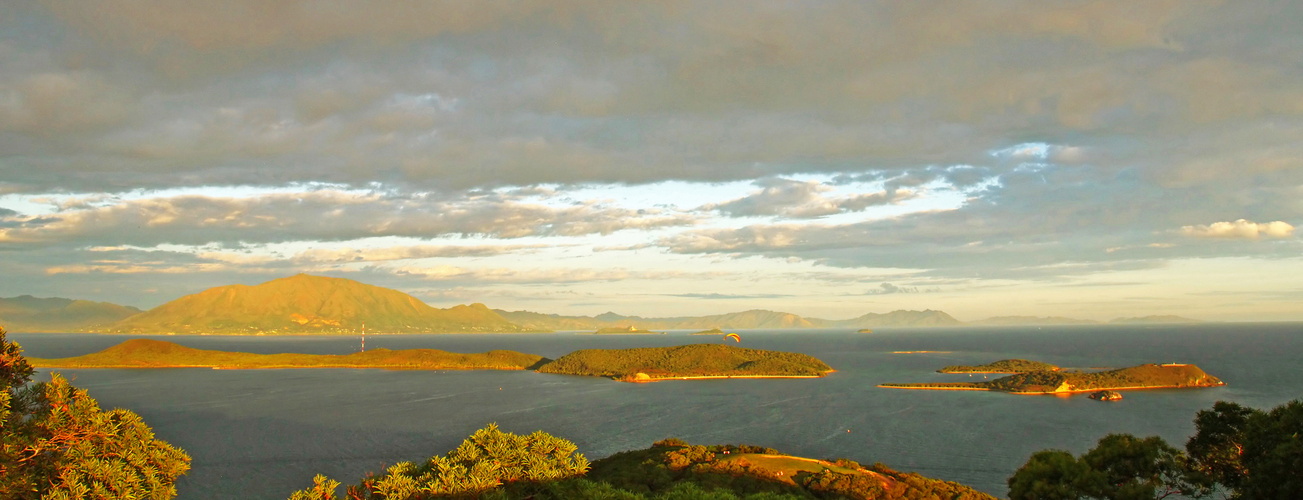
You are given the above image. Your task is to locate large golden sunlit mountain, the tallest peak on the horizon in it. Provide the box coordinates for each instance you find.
[109,275,523,333]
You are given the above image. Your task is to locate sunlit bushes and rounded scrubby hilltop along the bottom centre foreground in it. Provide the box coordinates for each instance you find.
[291,424,993,500]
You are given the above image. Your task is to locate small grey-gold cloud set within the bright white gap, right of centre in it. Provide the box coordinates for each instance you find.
[698,177,916,219]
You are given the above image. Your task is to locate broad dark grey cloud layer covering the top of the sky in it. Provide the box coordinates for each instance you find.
[0,1,1303,191]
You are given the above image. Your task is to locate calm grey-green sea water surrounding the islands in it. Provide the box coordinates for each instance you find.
[10,323,1303,499]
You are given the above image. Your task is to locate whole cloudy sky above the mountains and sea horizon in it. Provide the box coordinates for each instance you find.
[0,0,1303,320]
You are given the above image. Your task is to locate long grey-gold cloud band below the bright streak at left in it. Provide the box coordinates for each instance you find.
[0,190,696,246]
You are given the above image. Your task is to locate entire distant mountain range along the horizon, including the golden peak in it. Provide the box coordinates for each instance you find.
[0,275,1197,335]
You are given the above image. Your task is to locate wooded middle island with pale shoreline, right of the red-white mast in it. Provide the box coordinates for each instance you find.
[536,344,833,383]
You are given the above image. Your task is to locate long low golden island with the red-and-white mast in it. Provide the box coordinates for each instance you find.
[27,339,551,370]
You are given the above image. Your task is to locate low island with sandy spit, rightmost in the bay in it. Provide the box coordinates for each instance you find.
[878,363,1225,395]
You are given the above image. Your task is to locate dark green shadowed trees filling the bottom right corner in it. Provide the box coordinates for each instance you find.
[1009,400,1303,500]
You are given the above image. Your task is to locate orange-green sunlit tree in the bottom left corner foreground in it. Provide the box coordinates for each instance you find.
[0,328,190,499]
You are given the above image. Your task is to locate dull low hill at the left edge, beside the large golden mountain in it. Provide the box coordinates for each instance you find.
[0,296,141,332]
